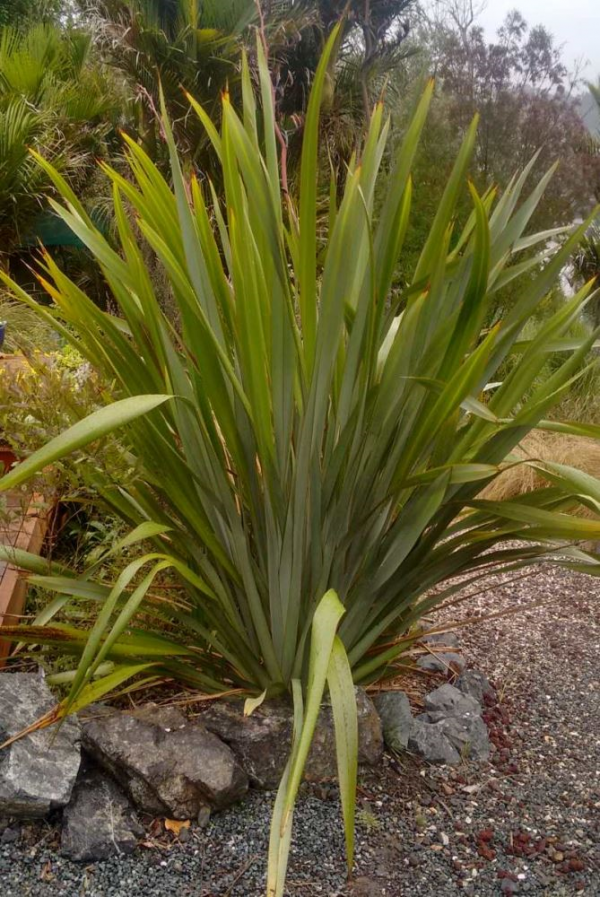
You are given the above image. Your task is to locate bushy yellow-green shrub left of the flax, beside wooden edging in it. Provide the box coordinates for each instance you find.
[0,344,136,636]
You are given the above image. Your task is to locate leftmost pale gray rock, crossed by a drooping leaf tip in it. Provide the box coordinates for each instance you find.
[0,673,81,818]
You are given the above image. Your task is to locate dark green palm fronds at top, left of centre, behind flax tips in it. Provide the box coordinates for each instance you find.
[79,0,257,167]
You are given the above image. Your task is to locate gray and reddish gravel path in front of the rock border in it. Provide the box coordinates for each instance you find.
[0,568,600,897]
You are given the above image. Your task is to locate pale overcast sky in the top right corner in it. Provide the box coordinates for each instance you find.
[478,0,600,81]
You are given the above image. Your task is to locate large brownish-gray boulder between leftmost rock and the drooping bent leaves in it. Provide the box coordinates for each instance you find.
[82,705,248,819]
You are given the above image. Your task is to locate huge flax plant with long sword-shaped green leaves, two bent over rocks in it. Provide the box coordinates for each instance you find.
[0,31,600,895]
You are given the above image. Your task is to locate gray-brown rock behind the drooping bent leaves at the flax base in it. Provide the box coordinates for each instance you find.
[202,688,383,789]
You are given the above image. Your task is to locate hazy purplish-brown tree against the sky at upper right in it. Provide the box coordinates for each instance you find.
[418,8,597,225]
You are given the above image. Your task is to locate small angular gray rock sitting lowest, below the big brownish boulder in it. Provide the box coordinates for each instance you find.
[60,769,144,863]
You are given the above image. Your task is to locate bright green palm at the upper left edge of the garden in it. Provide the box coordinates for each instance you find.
[0,25,119,253]
